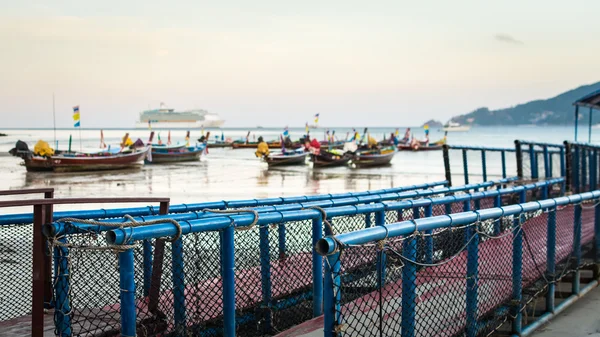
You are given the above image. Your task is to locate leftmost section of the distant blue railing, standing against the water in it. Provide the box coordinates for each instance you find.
[443,145,517,185]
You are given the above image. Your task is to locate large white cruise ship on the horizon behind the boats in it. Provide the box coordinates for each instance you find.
[135,103,225,129]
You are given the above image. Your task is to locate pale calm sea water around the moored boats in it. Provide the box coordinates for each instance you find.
[0,126,587,214]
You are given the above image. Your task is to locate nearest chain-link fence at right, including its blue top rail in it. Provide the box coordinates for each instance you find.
[317,192,600,336]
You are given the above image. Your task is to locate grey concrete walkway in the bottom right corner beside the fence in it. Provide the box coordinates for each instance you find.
[532,287,600,337]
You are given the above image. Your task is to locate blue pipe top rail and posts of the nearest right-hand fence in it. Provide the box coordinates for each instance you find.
[315,191,600,337]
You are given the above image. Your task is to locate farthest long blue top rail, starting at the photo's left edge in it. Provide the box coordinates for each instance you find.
[0,180,448,226]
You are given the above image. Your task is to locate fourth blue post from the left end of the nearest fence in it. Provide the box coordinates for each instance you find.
[512,189,526,335]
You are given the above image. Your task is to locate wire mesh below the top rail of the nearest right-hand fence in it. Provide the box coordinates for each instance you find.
[328,202,598,336]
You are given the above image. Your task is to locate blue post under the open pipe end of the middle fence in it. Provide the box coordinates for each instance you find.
[119,249,136,336]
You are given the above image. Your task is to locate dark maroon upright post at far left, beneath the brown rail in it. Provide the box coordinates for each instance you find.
[31,205,46,337]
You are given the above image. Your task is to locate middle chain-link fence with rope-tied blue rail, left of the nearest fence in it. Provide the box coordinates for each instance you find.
[39,179,562,336]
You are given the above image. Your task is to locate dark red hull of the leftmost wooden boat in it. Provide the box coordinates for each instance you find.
[19,147,150,172]
